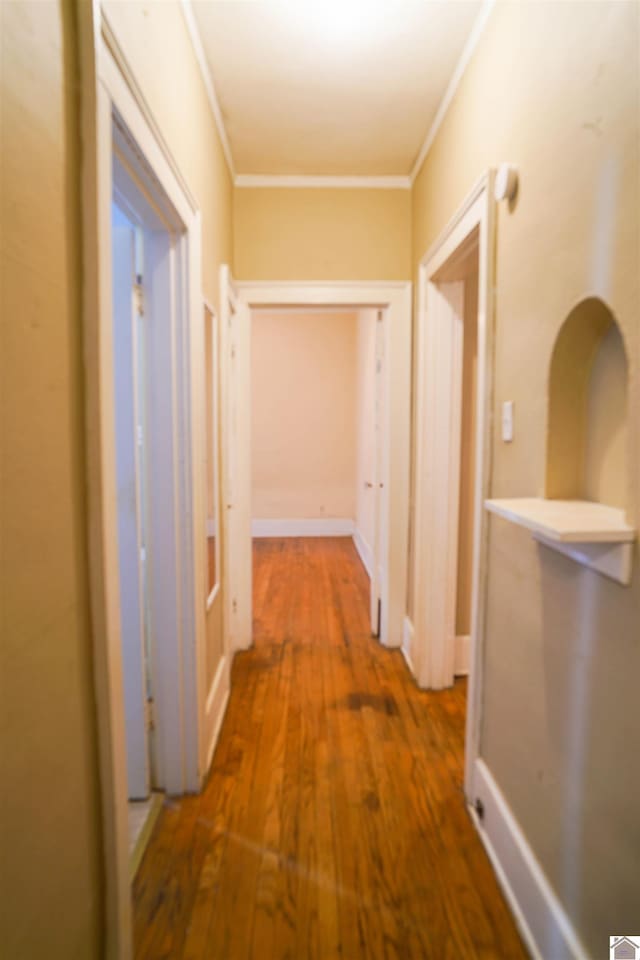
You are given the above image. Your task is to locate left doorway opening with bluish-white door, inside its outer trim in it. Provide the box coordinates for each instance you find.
[111,133,189,873]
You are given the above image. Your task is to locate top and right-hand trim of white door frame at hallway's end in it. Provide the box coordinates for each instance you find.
[236,281,411,647]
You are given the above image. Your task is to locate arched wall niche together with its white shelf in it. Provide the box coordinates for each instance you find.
[486,297,636,584]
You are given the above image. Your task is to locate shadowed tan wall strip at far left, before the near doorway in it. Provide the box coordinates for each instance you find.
[0,3,103,960]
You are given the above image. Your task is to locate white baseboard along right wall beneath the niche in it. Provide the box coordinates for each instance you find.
[470,760,588,960]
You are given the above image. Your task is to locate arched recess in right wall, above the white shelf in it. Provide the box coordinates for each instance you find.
[545,297,629,509]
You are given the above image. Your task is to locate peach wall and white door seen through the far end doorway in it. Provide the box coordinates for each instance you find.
[251,306,387,637]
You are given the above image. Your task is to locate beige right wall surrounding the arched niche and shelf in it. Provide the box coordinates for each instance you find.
[413,2,640,956]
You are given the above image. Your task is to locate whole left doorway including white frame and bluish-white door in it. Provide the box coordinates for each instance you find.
[81,26,208,956]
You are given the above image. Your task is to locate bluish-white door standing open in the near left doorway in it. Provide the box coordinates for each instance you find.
[112,204,149,799]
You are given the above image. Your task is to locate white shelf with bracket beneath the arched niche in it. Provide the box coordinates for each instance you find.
[485,497,636,584]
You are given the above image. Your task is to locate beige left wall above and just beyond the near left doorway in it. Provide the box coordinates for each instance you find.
[103,0,233,680]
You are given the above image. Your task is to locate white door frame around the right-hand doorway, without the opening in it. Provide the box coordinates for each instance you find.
[410,170,495,797]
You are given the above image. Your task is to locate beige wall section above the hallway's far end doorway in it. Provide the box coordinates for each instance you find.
[233,187,411,280]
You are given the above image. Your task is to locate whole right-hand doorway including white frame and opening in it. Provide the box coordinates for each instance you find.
[405,172,494,797]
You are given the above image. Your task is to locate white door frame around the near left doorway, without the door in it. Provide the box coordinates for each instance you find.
[76,0,206,960]
